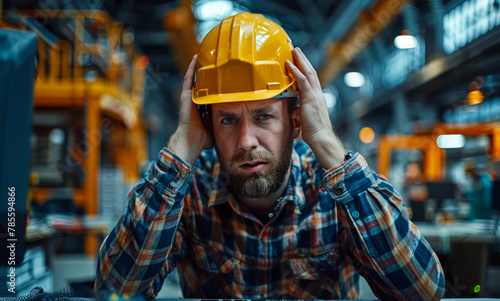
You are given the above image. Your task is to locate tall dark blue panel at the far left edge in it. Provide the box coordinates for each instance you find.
[0,28,38,267]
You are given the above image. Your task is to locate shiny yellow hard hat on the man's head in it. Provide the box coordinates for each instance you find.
[193,12,295,105]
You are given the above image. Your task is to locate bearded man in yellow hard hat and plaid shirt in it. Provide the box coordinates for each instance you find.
[96,13,444,300]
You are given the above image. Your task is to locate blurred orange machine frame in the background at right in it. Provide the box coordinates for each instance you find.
[378,123,500,181]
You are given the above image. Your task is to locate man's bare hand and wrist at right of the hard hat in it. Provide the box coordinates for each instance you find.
[287,47,347,169]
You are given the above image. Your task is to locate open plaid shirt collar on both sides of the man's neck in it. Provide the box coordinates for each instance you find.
[208,145,305,212]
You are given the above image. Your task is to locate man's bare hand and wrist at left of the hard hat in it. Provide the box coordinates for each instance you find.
[167,55,213,164]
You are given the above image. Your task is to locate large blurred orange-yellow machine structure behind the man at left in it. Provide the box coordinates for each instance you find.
[0,10,147,255]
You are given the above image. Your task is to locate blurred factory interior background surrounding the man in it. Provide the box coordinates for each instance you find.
[0,0,500,300]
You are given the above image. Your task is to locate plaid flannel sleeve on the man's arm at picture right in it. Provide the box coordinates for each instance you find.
[322,154,445,300]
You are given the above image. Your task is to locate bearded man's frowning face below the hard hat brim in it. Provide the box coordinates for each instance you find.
[212,99,300,198]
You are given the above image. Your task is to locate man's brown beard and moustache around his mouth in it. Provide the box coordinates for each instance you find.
[216,133,293,199]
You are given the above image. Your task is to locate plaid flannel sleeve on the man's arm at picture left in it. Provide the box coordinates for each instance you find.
[95,148,194,299]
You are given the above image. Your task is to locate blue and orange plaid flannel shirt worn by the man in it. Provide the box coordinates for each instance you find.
[96,142,445,300]
